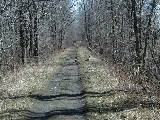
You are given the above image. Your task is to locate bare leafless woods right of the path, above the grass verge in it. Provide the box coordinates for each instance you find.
[78,0,160,92]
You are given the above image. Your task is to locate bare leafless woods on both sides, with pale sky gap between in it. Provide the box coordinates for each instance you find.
[0,0,160,97]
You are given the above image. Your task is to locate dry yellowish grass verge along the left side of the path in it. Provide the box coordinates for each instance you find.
[0,48,73,119]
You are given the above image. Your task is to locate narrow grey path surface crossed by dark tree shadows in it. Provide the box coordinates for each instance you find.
[28,51,85,120]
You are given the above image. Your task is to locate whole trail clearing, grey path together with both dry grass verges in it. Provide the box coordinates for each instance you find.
[0,47,160,120]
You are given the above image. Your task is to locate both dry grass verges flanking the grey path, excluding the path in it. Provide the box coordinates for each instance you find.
[0,47,160,120]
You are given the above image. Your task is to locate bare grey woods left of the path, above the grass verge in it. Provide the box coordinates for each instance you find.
[0,0,73,72]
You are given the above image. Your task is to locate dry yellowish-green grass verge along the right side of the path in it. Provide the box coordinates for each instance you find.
[78,47,160,120]
